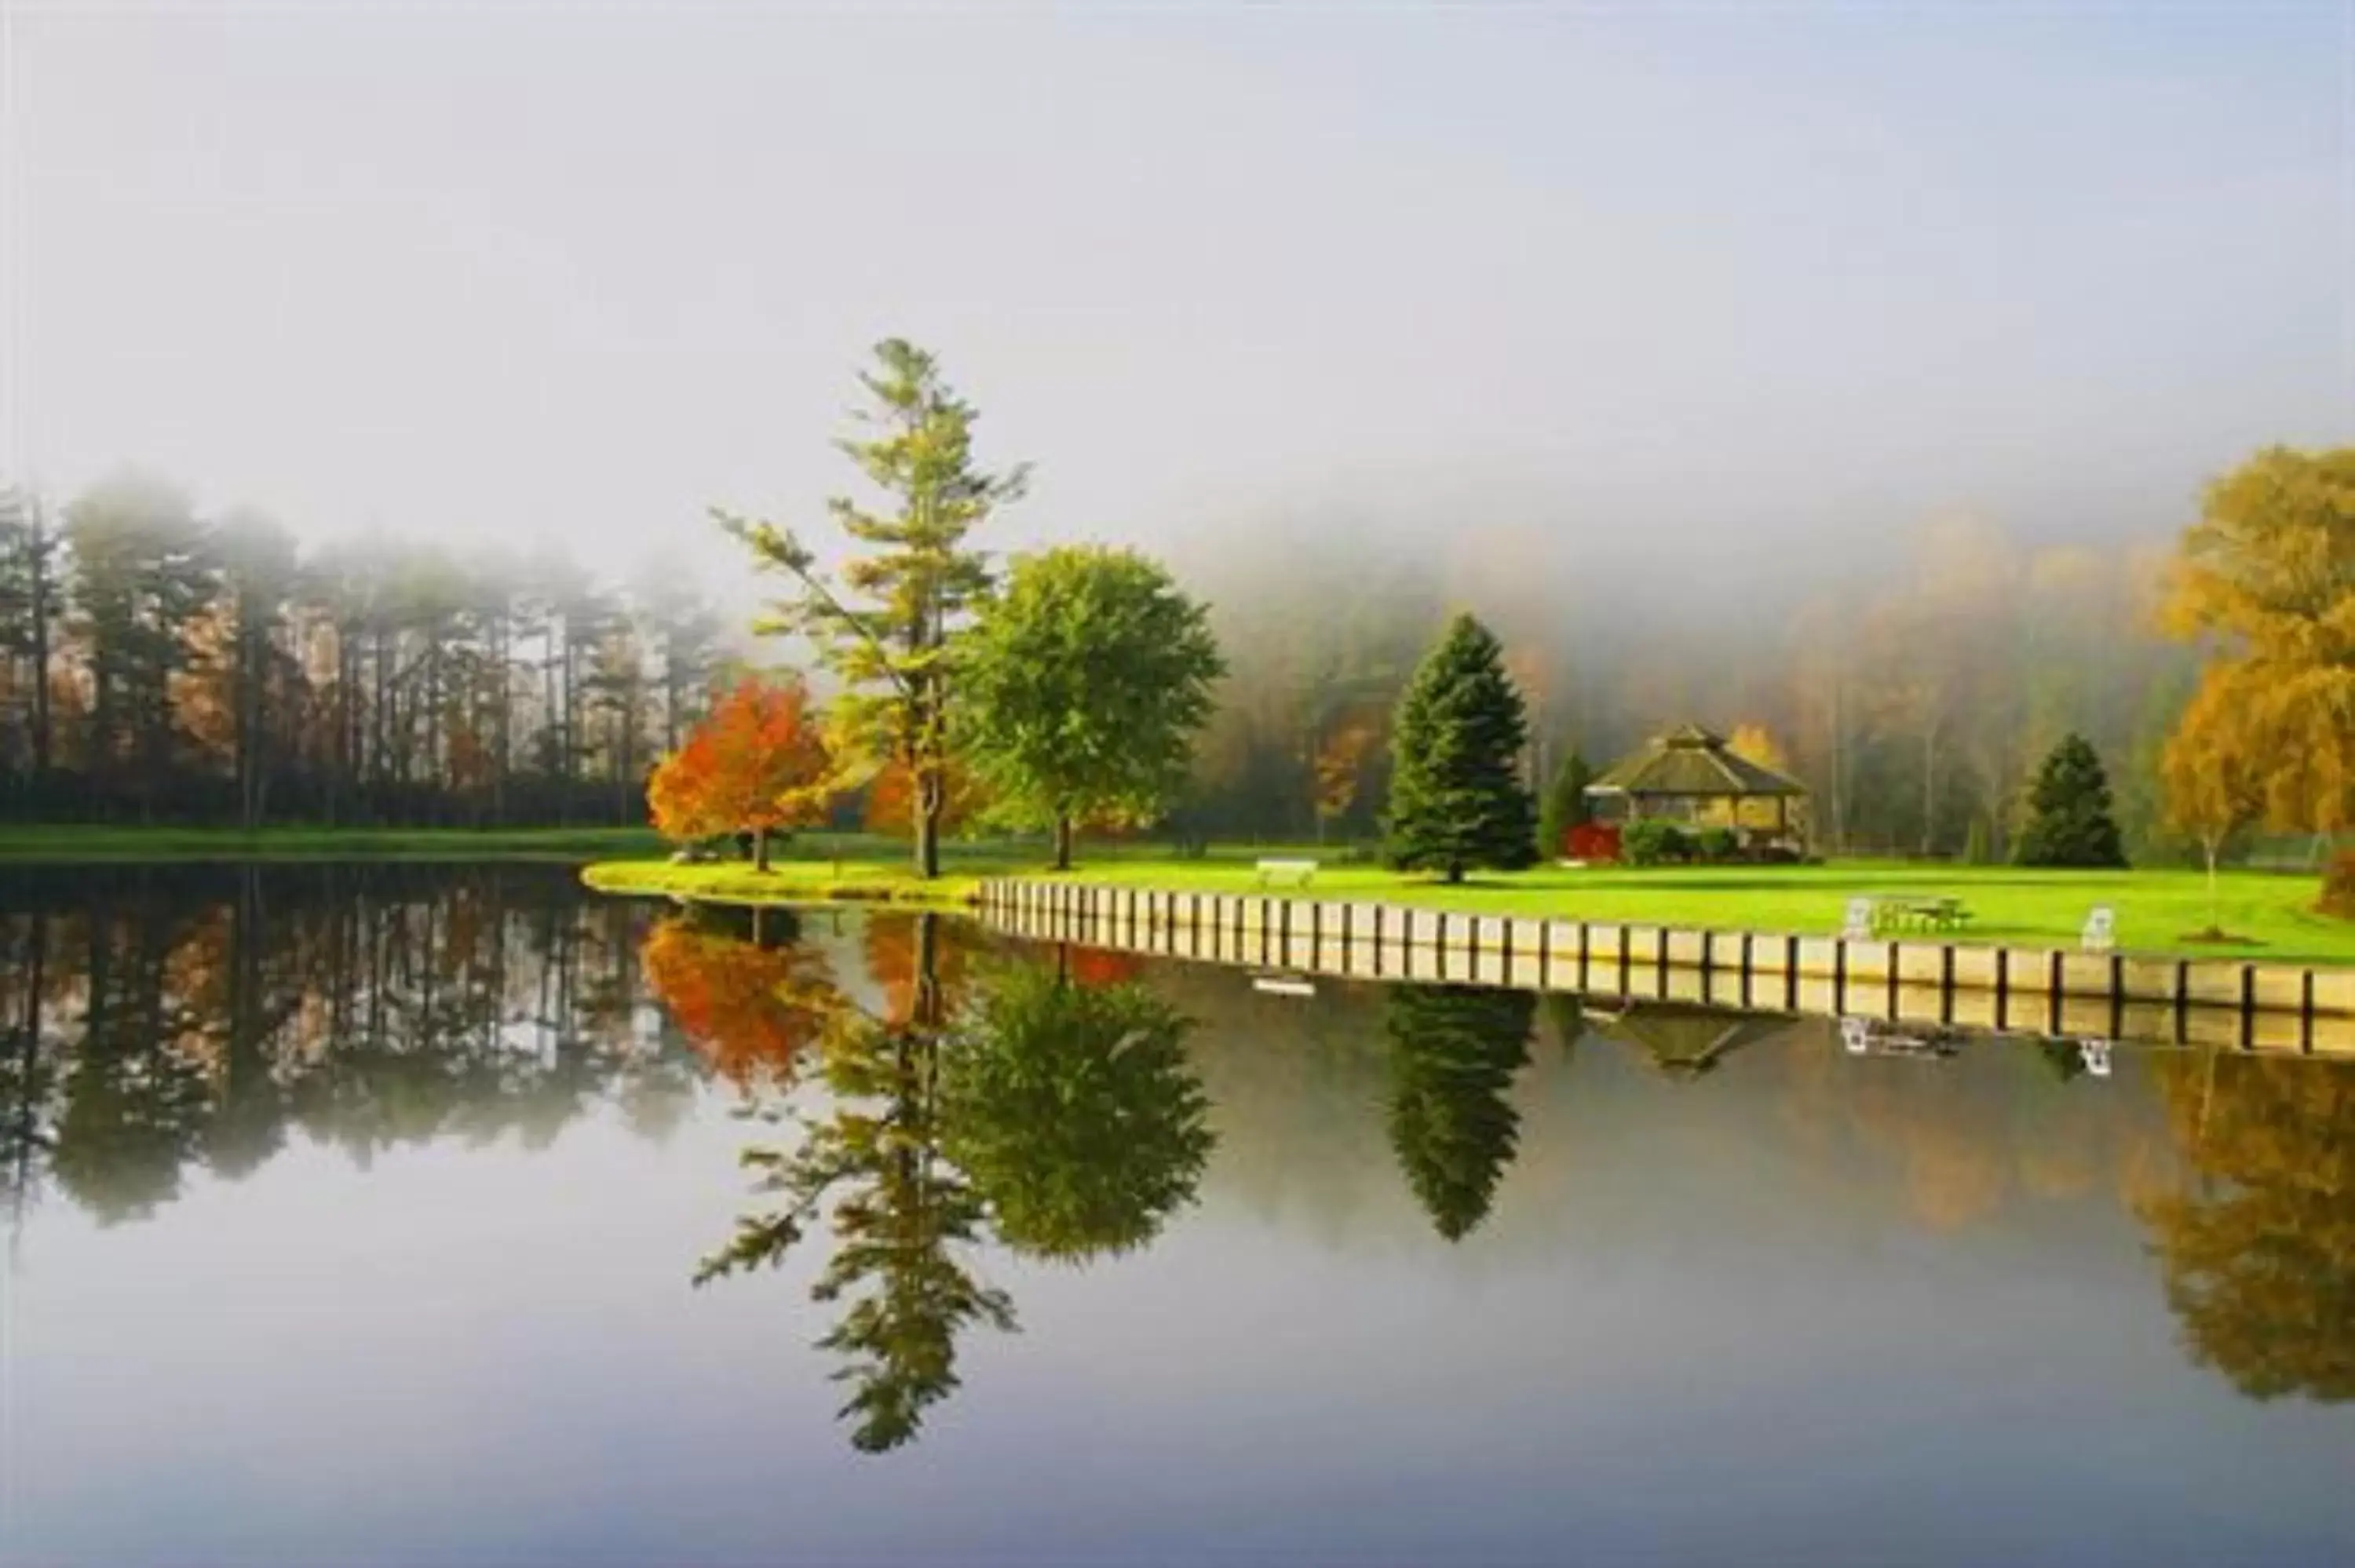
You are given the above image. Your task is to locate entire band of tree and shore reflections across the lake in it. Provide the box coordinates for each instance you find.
[0,866,2355,1479]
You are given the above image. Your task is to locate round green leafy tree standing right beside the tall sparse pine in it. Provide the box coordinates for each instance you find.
[958,546,1225,869]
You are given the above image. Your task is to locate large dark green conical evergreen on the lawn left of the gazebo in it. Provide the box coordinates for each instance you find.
[1387,614,1538,883]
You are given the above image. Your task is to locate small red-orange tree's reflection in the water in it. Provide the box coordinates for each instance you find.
[641,918,841,1085]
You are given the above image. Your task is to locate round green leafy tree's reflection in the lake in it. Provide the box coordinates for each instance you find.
[942,965,1215,1262]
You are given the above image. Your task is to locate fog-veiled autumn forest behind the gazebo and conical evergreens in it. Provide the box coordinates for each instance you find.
[1189,518,2200,859]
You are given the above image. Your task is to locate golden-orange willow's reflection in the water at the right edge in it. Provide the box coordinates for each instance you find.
[2141,1055,2355,1401]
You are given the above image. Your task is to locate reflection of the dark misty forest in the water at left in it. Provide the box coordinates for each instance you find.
[0,866,695,1224]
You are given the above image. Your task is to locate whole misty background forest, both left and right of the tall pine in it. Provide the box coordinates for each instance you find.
[0,476,2200,859]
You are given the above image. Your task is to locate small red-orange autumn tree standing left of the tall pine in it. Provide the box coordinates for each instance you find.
[645,676,834,871]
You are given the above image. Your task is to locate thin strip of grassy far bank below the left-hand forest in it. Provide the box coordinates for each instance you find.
[0,824,664,862]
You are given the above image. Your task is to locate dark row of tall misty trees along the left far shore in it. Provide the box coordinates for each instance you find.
[0,473,728,829]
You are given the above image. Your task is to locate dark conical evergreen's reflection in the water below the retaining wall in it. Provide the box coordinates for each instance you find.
[1385,984,1538,1241]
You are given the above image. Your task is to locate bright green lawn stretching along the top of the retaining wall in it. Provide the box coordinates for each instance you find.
[589,843,2355,963]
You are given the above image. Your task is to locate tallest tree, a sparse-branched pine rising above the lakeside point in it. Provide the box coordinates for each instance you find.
[714,339,1027,878]
